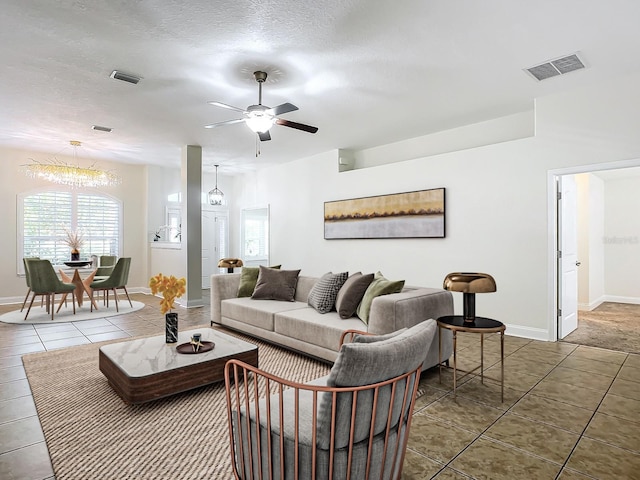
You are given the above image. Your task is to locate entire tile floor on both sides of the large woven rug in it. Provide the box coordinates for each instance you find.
[0,292,640,480]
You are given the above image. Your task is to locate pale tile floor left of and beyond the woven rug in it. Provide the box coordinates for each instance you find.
[0,290,209,480]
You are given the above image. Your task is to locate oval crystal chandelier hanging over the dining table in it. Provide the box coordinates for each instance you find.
[24,140,122,188]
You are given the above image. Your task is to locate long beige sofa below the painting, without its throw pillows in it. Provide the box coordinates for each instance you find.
[210,273,453,369]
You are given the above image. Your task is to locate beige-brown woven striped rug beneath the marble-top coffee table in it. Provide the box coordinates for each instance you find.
[23,326,329,480]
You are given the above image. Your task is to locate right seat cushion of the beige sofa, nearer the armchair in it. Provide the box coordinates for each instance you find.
[274,308,365,352]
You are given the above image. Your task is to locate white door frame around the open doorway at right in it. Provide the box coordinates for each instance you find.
[547,158,640,342]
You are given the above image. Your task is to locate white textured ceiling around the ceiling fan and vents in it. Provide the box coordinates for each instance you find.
[0,0,640,173]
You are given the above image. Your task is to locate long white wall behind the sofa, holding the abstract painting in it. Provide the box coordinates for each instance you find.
[236,72,640,339]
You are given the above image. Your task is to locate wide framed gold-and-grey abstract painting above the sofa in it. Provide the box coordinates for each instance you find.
[324,188,445,240]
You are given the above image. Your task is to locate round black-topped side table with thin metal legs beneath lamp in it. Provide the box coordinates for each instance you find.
[437,315,506,402]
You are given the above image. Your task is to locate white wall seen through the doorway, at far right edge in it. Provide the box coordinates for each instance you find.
[603,177,640,303]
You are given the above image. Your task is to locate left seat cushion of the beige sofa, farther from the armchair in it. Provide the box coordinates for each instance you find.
[220,297,309,332]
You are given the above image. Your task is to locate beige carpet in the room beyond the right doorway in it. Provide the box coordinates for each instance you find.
[563,302,640,353]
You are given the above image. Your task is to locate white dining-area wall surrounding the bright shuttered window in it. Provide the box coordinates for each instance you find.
[0,147,148,302]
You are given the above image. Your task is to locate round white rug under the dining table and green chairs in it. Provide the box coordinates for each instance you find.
[0,298,145,324]
